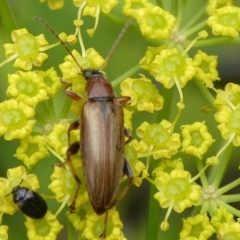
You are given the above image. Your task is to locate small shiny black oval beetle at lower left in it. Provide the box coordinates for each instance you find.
[7,183,48,219]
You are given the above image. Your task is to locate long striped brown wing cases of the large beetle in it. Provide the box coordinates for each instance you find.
[81,74,125,214]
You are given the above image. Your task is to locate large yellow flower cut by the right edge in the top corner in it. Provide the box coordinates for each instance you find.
[207,6,240,38]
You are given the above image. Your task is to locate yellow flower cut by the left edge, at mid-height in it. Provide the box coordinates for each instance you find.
[0,99,36,140]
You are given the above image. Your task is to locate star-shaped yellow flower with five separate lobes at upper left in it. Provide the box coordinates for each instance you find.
[4,28,48,70]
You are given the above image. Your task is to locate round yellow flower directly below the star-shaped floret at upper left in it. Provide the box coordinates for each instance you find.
[7,71,48,106]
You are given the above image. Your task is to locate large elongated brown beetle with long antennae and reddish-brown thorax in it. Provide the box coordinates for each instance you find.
[35,17,133,239]
